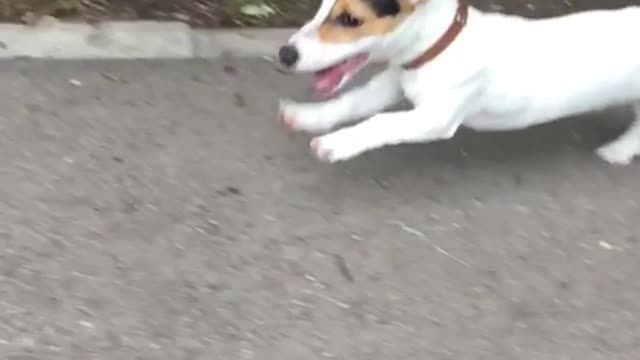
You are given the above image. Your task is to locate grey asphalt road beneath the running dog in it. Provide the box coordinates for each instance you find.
[0,59,640,360]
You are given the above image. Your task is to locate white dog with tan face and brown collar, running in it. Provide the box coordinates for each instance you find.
[278,0,640,165]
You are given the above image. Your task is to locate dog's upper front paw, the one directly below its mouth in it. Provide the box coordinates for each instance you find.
[278,100,333,133]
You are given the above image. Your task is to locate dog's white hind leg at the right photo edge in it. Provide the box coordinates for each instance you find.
[596,102,640,165]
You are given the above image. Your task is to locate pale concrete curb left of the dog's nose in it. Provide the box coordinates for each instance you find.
[0,21,294,60]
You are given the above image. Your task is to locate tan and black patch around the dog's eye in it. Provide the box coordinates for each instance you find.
[318,0,415,43]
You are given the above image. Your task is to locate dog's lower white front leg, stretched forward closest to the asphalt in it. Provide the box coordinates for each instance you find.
[311,106,461,162]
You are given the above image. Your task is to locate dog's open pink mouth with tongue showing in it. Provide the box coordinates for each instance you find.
[313,54,369,98]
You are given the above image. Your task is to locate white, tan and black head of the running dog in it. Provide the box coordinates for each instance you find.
[279,0,423,95]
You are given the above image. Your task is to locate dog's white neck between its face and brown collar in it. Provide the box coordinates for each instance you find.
[383,0,464,66]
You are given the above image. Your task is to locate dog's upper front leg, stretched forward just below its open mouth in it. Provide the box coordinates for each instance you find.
[280,69,402,133]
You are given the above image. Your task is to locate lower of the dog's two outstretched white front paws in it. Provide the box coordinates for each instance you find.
[309,130,364,163]
